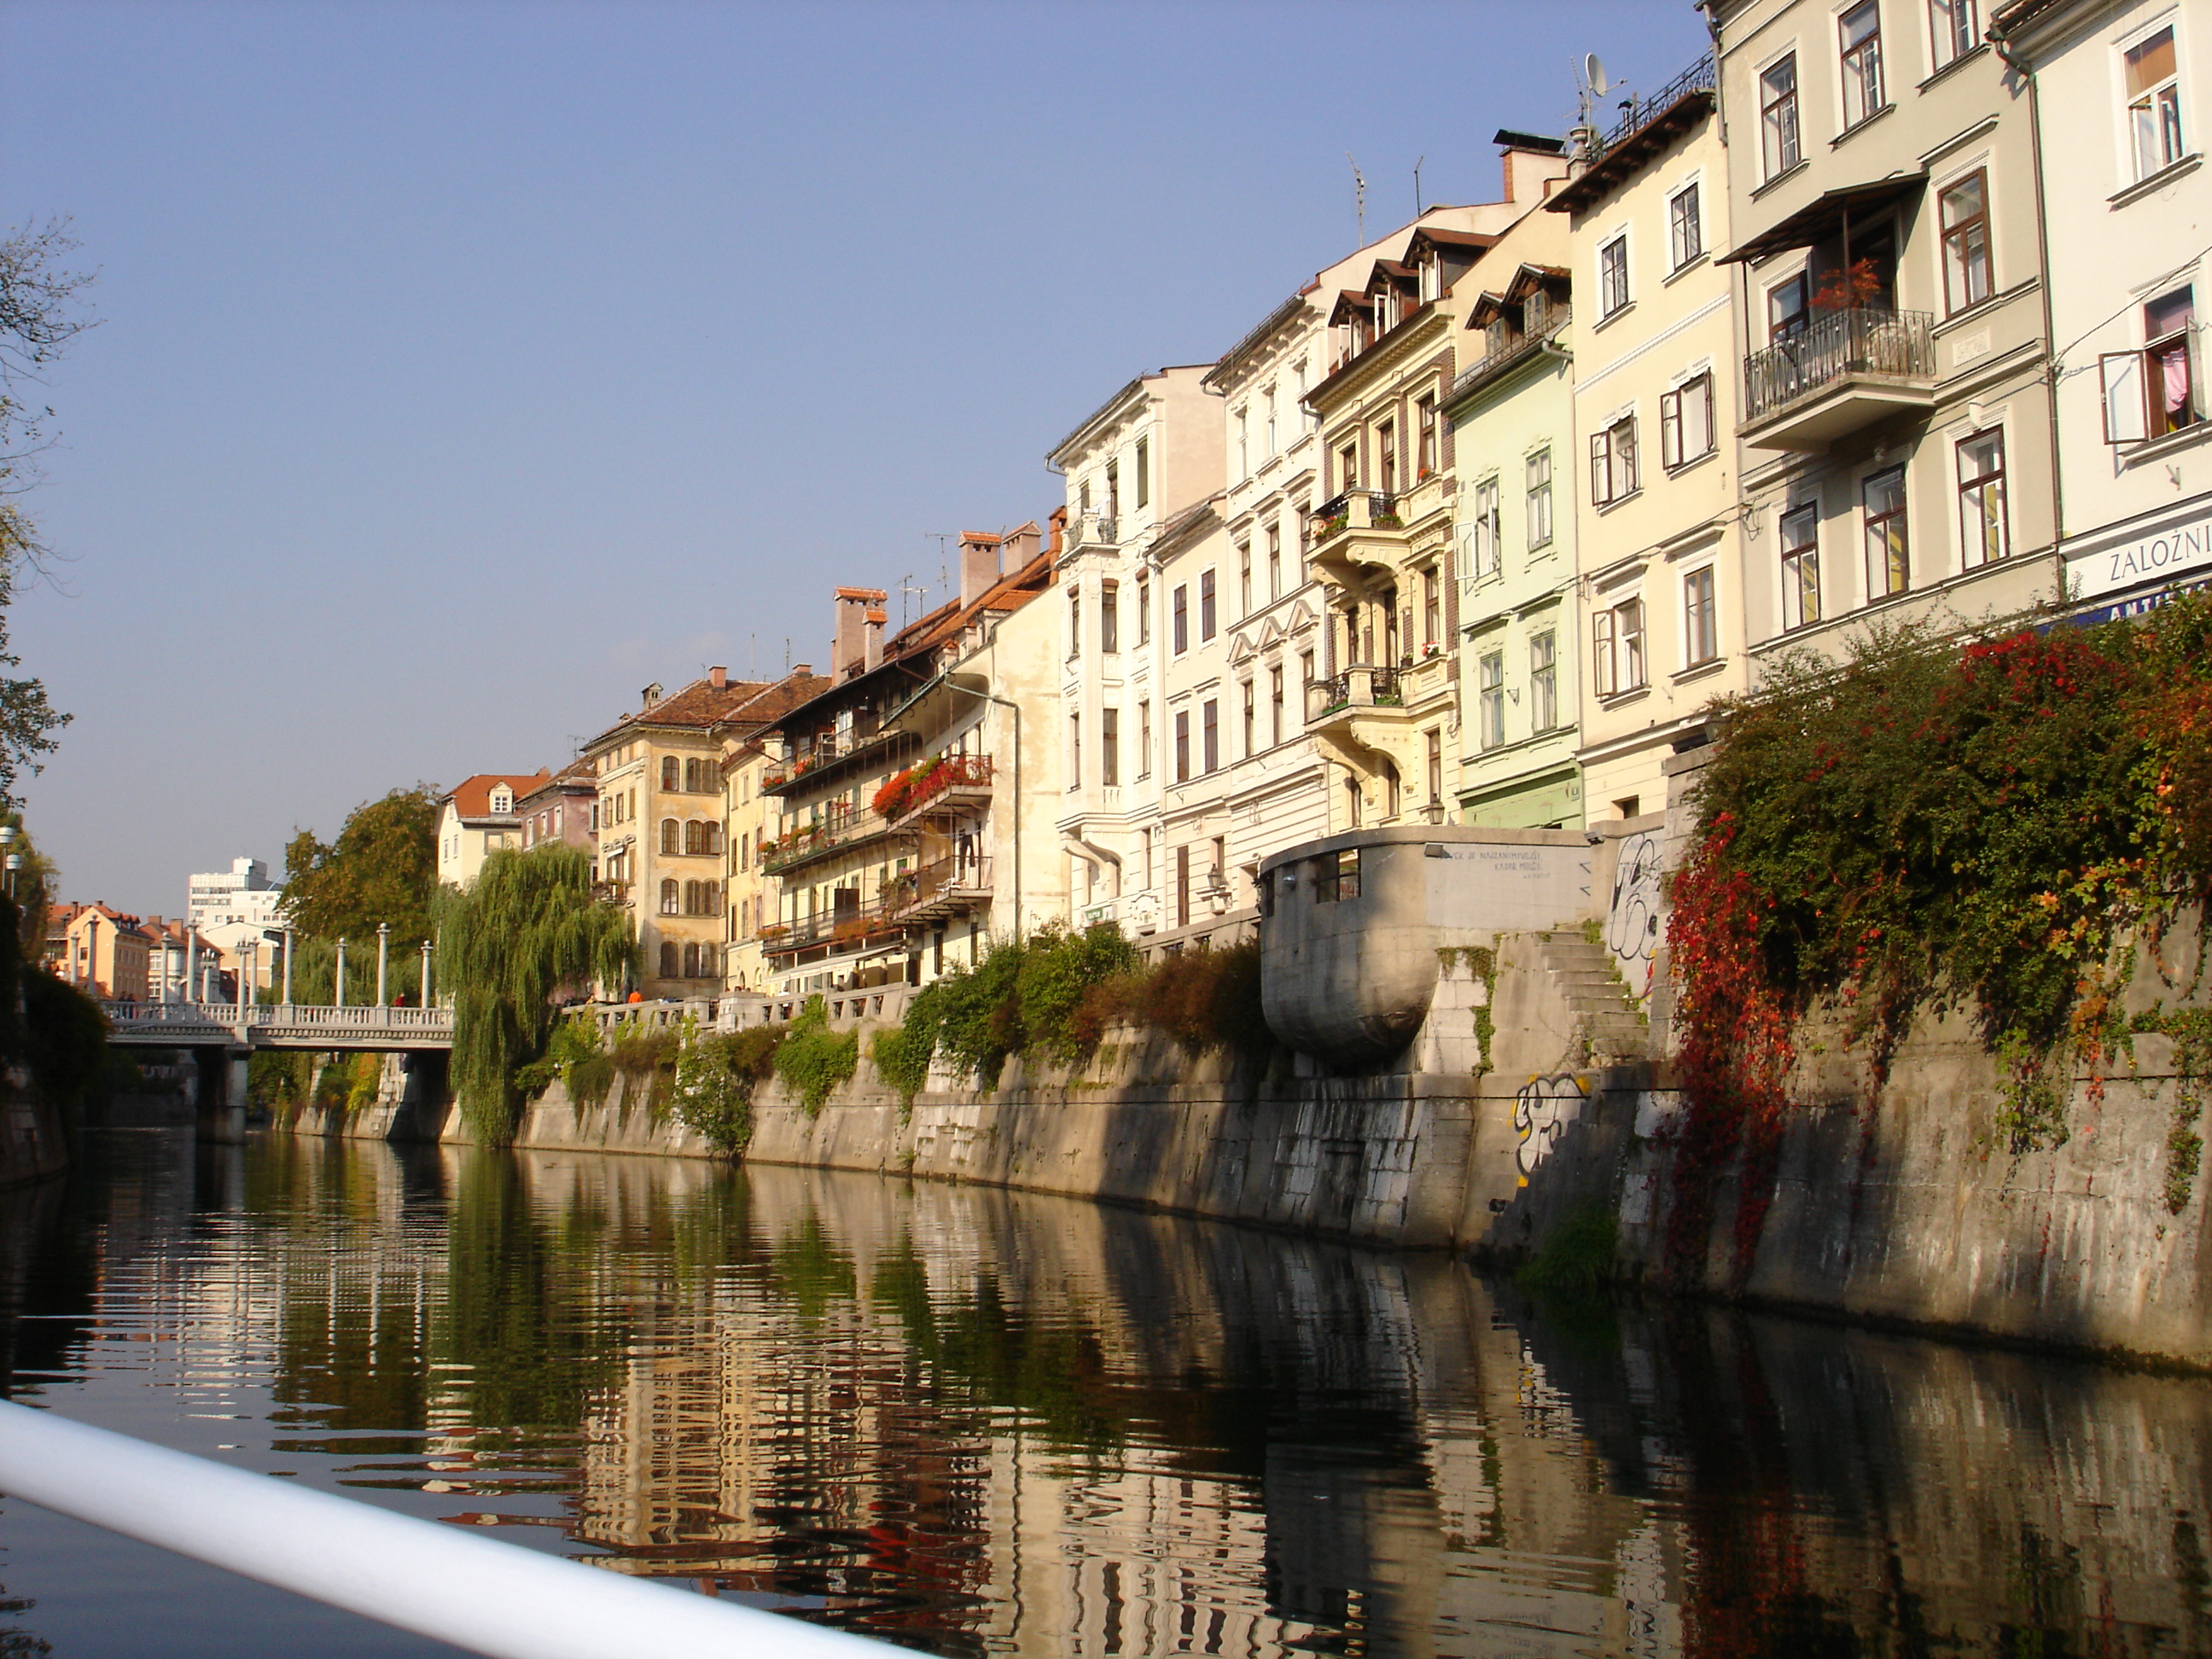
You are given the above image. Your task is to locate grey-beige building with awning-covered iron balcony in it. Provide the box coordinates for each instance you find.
[1708,0,2052,663]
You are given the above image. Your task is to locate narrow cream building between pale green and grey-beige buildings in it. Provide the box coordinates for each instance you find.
[1546,57,1749,821]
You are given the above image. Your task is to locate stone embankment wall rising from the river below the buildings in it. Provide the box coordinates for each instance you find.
[301,927,2212,1365]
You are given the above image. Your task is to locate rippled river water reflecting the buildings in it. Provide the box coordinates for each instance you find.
[0,1131,2212,1659]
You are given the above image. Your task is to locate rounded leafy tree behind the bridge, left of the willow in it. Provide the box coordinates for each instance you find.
[283,783,438,946]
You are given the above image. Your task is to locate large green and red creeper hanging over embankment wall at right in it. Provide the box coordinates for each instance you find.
[1668,597,2212,1274]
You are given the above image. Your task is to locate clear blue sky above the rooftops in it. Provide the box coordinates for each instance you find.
[0,0,1705,913]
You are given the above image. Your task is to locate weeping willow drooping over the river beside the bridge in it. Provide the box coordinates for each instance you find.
[438,843,637,1146]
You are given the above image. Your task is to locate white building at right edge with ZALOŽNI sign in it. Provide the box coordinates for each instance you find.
[2000,0,2212,617]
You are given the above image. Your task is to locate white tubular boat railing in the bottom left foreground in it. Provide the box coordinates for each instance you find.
[0,1402,905,1659]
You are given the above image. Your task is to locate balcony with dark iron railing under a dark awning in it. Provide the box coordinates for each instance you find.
[1741,306,1936,451]
